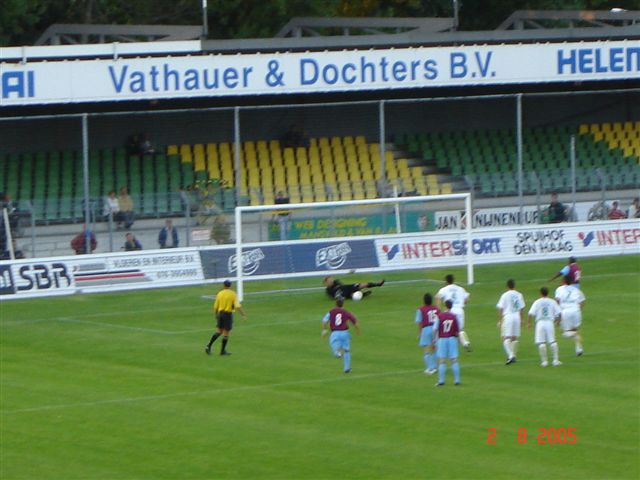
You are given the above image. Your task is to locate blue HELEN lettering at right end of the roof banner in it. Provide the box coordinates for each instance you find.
[557,47,640,75]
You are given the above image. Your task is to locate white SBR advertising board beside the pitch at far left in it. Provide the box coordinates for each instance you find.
[0,249,204,299]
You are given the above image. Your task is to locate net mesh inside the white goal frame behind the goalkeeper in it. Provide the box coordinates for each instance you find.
[234,194,470,298]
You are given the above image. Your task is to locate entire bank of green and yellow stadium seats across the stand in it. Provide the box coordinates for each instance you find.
[0,122,640,223]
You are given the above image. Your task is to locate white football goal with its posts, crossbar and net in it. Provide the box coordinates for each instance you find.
[229,192,474,300]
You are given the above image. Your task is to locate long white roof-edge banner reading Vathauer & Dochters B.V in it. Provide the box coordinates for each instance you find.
[0,40,640,106]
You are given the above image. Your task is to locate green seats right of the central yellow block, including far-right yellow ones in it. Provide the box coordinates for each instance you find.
[396,122,640,196]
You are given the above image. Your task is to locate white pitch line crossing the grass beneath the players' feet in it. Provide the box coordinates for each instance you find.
[1,349,635,415]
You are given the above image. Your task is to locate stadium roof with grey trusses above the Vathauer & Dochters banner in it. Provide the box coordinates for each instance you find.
[0,10,640,61]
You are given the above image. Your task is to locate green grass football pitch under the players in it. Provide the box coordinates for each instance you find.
[0,256,640,480]
